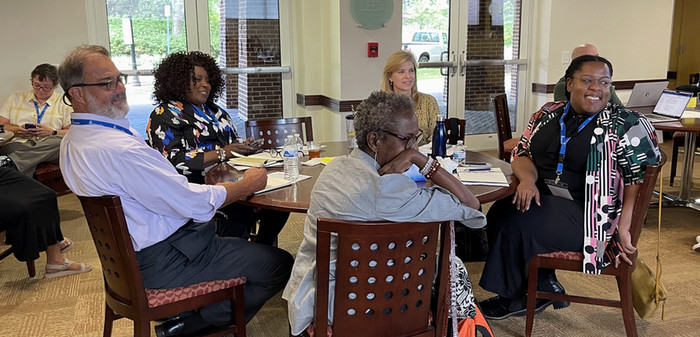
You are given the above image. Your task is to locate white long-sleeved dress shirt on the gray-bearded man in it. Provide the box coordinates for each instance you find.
[60,113,226,251]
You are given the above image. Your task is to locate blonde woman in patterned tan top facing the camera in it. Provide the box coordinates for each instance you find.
[381,50,440,146]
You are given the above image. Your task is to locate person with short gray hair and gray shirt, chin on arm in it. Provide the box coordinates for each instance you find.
[282,91,485,336]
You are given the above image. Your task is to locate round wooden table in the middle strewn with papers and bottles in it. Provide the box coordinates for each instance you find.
[205,142,517,213]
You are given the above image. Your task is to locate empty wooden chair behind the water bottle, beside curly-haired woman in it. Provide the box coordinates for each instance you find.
[245,117,314,149]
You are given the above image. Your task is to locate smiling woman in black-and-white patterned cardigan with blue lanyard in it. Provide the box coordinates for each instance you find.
[479,55,660,319]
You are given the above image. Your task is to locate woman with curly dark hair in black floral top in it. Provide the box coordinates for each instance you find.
[146,51,289,244]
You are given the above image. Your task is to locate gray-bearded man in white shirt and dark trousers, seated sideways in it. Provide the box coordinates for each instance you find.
[59,46,293,336]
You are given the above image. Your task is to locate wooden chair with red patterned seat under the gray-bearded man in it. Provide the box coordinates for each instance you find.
[78,196,246,337]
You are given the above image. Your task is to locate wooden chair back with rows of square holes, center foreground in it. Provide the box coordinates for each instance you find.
[315,218,450,337]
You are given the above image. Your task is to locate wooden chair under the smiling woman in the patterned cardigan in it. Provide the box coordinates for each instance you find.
[525,155,666,336]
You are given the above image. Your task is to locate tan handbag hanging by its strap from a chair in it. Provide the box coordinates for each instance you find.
[632,169,666,319]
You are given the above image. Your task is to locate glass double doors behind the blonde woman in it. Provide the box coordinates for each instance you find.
[403,0,527,150]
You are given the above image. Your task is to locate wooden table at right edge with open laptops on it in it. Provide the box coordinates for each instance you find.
[634,107,700,211]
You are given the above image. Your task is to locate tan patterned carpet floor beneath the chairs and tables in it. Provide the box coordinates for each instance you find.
[0,143,700,337]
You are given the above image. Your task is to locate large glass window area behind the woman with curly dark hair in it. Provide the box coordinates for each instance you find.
[92,0,289,137]
